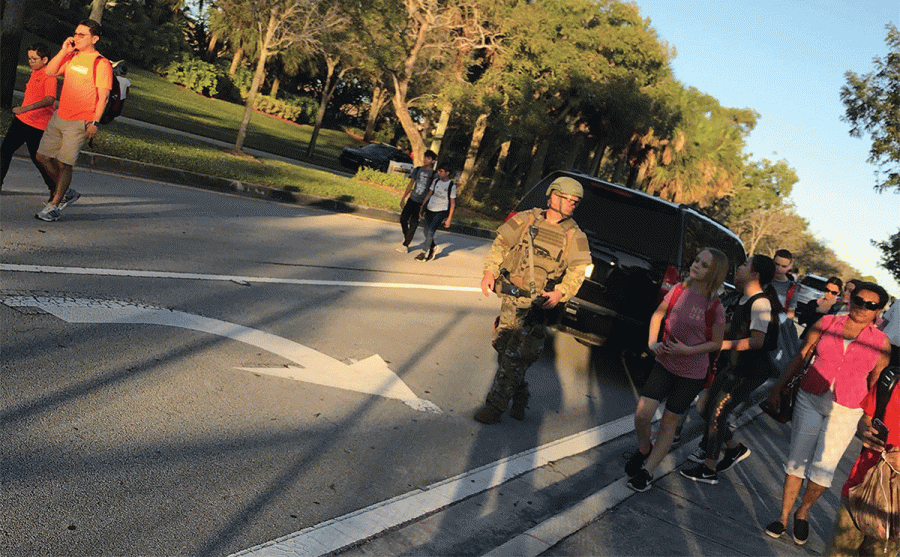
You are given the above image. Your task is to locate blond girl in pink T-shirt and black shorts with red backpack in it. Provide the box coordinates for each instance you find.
[625,248,728,492]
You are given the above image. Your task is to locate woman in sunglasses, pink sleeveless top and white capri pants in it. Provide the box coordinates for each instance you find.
[766,282,891,545]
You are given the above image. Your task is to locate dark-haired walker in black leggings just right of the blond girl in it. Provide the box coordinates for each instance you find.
[681,255,777,485]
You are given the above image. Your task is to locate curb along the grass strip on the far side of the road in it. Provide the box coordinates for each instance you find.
[76,151,496,238]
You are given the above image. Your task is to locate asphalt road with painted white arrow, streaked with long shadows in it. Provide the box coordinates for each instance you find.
[0,159,635,555]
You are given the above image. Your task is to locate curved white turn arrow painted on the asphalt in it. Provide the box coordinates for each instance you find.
[3,295,441,413]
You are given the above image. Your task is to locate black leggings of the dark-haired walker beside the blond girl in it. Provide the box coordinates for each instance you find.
[700,370,754,460]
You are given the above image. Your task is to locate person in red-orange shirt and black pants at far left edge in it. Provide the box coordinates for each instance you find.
[0,43,56,192]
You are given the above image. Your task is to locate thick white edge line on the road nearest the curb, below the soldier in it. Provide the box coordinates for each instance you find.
[234,415,634,557]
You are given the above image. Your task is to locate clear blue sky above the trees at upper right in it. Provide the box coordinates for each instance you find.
[634,0,900,297]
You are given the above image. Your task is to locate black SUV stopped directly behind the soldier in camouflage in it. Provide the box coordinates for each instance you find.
[516,172,746,351]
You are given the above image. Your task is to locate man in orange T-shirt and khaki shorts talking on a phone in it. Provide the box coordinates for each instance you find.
[35,19,113,222]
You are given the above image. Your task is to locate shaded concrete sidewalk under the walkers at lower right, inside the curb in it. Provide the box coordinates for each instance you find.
[536,404,860,556]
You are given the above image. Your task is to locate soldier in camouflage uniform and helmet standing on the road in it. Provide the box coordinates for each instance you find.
[475,177,591,424]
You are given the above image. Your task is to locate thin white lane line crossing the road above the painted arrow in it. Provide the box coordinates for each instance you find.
[0,263,481,292]
